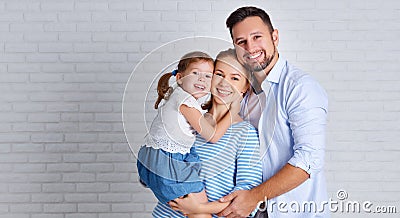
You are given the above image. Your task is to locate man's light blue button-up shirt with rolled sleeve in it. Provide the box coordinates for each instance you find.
[241,57,329,218]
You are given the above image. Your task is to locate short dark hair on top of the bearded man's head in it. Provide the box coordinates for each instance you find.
[226,6,274,39]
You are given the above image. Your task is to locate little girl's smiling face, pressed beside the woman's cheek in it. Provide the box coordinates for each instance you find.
[176,61,214,99]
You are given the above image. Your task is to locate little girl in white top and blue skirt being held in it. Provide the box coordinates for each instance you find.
[137,52,240,217]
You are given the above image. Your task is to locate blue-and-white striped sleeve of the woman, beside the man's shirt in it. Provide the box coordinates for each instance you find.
[234,124,262,190]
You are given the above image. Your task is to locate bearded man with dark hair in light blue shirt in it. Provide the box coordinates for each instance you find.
[219,7,329,218]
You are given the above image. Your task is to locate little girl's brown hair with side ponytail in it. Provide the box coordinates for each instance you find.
[154,51,214,109]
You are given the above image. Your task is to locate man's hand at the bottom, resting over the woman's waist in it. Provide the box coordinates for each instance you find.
[218,189,258,218]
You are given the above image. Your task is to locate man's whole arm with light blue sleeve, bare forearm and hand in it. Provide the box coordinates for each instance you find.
[220,78,327,217]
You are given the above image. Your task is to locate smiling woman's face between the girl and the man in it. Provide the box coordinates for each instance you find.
[211,61,250,104]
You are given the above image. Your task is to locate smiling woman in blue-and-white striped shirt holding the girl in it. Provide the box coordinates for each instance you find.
[153,49,262,217]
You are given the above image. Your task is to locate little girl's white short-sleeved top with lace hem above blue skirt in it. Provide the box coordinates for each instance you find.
[145,86,205,154]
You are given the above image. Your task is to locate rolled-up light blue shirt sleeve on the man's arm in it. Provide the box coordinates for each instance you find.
[287,77,328,177]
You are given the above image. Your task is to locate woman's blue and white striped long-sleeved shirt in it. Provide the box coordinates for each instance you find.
[153,122,262,218]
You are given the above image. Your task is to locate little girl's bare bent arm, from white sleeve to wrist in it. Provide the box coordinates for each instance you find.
[179,104,232,143]
